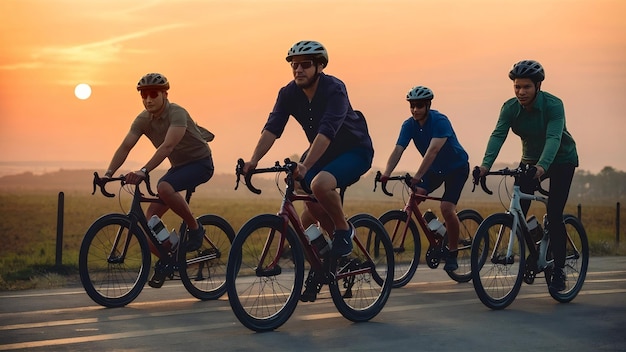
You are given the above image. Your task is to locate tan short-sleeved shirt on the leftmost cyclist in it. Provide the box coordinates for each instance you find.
[130,101,211,167]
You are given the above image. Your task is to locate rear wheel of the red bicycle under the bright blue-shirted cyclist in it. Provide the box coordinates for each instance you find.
[445,209,486,282]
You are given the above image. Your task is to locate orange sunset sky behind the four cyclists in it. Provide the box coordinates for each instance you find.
[0,0,626,177]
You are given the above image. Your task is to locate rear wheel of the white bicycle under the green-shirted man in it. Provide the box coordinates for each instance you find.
[545,214,589,303]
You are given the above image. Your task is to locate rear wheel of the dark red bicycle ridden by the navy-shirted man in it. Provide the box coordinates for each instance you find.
[329,214,394,322]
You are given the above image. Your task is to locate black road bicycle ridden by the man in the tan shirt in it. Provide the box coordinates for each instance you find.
[78,172,235,307]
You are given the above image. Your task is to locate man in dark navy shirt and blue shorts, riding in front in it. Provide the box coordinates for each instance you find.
[243,41,374,257]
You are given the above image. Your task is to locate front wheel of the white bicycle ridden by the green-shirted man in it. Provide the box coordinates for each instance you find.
[471,213,526,309]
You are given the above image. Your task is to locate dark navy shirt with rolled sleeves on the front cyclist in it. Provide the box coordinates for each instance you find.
[263,73,374,164]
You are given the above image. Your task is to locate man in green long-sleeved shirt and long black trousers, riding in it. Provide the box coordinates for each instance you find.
[480,60,578,292]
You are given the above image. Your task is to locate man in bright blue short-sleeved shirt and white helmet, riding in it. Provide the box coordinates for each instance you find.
[381,86,469,271]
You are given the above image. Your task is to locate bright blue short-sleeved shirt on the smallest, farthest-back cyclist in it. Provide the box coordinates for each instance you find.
[396,110,469,174]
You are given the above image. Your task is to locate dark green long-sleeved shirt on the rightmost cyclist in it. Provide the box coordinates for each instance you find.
[482,91,578,171]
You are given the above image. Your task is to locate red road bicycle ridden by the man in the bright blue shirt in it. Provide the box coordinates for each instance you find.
[374,171,483,288]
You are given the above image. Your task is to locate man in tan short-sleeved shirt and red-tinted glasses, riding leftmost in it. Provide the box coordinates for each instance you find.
[104,73,214,272]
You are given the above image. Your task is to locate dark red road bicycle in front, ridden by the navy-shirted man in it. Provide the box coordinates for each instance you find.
[226,159,393,331]
